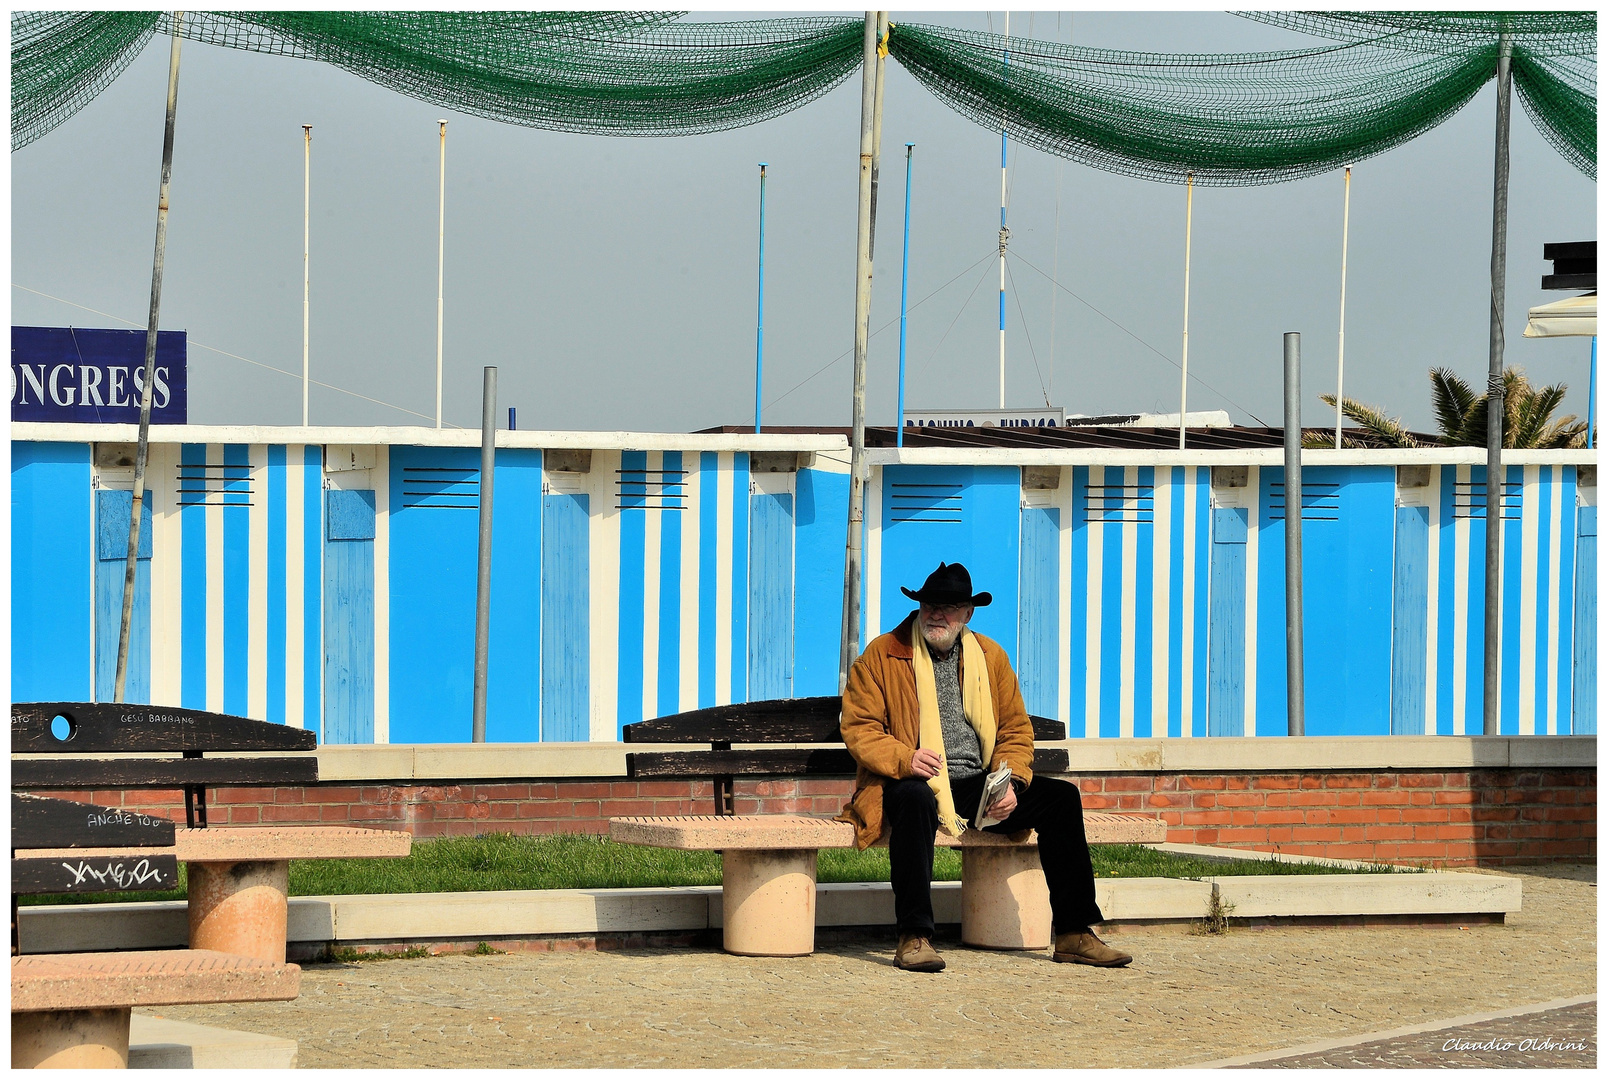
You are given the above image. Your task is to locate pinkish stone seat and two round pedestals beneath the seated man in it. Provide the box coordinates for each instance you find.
[609,812,1167,956]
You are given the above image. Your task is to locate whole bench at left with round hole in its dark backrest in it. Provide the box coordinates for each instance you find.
[11,701,412,963]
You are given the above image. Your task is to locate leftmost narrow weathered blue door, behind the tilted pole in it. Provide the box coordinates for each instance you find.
[95,490,153,704]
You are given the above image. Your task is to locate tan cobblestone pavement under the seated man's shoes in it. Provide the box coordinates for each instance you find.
[159,866,1597,1069]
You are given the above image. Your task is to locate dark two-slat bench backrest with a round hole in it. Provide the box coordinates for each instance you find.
[11,701,318,826]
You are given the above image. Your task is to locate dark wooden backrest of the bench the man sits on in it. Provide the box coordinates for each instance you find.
[622,696,1068,815]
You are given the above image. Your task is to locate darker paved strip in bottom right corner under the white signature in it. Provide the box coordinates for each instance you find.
[1237,1001,1597,1069]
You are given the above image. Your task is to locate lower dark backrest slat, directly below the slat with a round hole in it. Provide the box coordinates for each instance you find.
[11,755,318,791]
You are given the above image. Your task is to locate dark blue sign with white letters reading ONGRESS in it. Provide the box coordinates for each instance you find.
[11,326,188,424]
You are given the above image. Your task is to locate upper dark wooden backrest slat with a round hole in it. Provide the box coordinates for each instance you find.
[11,701,318,754]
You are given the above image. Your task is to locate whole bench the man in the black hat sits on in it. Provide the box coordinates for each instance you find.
[609,698,1167,956]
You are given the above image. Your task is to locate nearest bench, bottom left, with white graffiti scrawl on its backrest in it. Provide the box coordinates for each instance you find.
[11,794,301,1069]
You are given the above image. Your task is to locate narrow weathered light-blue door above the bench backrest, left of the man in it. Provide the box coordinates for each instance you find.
[748,492,793,701]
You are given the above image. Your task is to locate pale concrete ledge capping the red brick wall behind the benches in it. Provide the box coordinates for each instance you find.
[307,734,1597,786]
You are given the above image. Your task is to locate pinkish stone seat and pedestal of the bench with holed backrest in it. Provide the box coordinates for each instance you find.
[16,824,413,963]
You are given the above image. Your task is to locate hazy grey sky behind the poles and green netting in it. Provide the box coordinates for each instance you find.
[11,11,1597,431]
